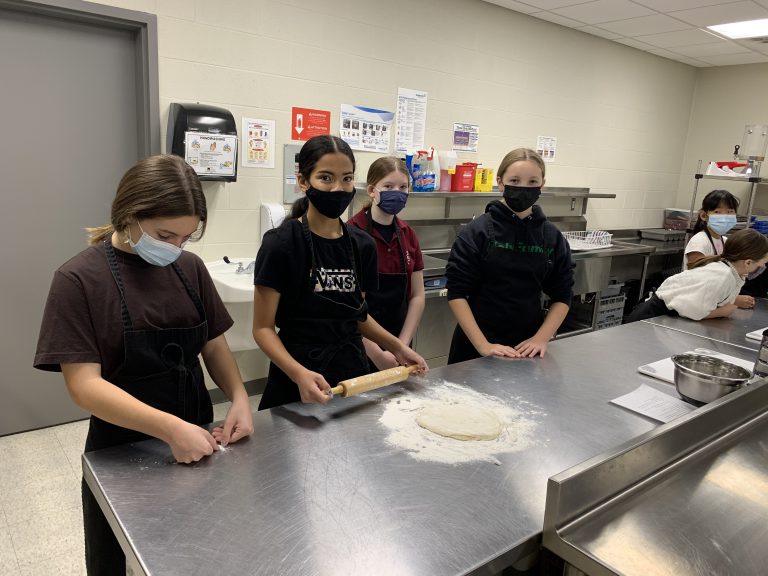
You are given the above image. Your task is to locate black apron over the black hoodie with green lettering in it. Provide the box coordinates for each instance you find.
[448,216,552,364]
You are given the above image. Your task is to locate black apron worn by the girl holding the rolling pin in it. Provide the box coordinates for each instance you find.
[259,216,369,410]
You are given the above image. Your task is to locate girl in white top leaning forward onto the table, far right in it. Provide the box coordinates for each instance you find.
[627,228,768,322]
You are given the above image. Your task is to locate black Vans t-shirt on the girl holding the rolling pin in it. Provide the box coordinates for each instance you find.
[254,220,378,327]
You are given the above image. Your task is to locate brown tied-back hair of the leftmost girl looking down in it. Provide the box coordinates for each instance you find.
[86,154,208,244]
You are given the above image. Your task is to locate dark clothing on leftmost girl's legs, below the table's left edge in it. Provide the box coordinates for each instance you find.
[82,479,125,576]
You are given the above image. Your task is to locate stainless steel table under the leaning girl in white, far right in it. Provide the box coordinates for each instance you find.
[643,298,768,351]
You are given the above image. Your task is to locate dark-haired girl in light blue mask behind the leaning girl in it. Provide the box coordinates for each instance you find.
[683,190,762,308]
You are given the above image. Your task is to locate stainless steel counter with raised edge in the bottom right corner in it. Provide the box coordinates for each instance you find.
[544,368,768,576]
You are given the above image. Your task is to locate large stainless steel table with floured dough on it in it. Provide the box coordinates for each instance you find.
[83,323,751,576]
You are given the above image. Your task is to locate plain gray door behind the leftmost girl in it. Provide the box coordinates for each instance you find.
[0,4,158,435]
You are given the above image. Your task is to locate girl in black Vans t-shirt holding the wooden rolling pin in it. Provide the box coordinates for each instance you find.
[253,136,427,409]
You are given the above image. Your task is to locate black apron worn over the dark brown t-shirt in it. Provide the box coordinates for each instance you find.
[82,238,213,576]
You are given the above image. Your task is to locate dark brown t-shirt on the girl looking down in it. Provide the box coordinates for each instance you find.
[34,242,233,378]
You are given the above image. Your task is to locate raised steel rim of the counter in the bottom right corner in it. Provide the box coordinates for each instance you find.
[543,380,768,576]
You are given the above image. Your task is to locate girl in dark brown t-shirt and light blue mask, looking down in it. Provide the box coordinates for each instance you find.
[35,156,253,575]
